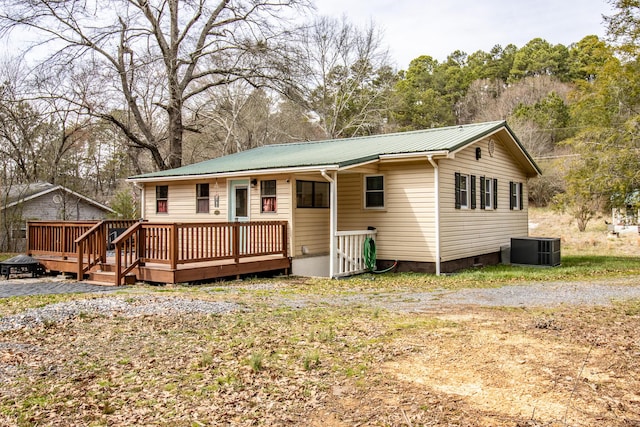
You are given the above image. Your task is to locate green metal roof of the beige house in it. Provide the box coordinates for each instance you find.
[130,121,537,180]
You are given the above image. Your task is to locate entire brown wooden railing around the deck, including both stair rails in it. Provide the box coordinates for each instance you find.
[27,220,288,284]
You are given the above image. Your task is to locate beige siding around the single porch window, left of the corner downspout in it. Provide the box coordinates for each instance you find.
[338,163,435,262]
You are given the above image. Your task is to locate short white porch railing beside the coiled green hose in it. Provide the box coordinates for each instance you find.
[332,230,376,277]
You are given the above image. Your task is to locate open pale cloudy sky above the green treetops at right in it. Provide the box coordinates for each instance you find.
[315,0,612,69]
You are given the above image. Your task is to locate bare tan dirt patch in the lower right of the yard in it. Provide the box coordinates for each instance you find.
[306,300,640,426]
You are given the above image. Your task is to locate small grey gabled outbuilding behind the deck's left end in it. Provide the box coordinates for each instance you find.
[0,182,114,252]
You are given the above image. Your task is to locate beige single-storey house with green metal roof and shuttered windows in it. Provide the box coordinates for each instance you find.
[129,121,540,277]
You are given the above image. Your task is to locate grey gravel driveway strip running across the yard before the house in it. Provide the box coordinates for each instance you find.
[0,277,640,332]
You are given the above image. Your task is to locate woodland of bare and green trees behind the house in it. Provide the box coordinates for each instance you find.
[0,0,640,231]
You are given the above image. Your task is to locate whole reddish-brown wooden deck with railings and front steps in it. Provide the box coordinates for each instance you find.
[27,221,291,285]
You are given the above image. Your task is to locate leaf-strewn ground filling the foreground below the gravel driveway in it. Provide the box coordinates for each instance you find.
[0,289,640,427]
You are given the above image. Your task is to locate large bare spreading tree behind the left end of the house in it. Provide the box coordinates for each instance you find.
[0,0,307,169]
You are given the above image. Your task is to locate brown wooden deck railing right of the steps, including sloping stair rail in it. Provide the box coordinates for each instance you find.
[114,221,288,284]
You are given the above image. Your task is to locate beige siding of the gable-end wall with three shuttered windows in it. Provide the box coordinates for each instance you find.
[439,136,528,261]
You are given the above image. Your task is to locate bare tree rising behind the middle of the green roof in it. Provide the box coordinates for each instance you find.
[302,17,395,138]
